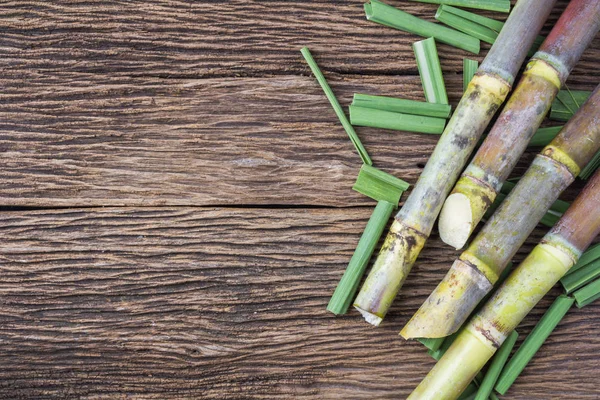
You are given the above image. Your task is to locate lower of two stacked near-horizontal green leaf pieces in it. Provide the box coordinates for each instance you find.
[350,106,446,135]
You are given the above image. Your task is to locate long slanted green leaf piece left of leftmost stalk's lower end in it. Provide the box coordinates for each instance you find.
[327,201,395,315]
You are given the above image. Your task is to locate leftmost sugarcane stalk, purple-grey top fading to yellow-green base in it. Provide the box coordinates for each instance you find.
[354,0,555,325]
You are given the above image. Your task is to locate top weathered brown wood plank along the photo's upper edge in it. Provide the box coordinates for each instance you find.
[0,0,600,78]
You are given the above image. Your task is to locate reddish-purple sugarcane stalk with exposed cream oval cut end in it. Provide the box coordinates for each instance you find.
[439,0,600,249]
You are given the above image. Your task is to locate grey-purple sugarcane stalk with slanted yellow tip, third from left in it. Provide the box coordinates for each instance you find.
[400,83,600,339]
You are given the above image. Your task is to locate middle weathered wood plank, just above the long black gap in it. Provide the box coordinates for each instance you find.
[0,72,594,207]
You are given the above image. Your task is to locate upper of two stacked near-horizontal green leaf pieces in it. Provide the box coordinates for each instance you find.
[352,93,452,118]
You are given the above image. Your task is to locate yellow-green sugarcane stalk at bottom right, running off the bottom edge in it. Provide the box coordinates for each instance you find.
[408,172,600,400]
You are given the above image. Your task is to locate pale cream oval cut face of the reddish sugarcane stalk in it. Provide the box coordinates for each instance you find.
[438,193,473,250]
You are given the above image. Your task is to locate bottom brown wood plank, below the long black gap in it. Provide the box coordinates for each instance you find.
[0,207,600,399]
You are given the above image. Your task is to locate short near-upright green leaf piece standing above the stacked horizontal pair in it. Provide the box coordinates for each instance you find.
[413,38,448,104]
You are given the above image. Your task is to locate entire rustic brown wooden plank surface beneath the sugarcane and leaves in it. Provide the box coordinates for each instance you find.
[0,0,600,399]
